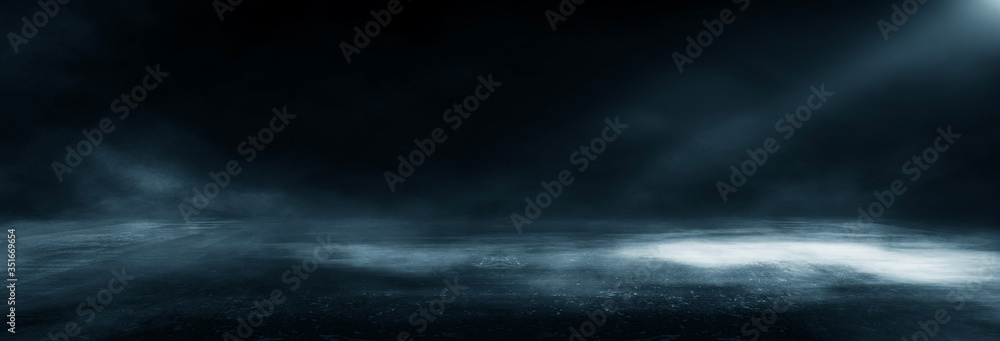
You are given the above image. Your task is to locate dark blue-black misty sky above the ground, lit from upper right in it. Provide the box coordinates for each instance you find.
[0,0,1000,227]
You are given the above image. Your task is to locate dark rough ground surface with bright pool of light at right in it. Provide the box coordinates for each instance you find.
[8,221,1000,340]
